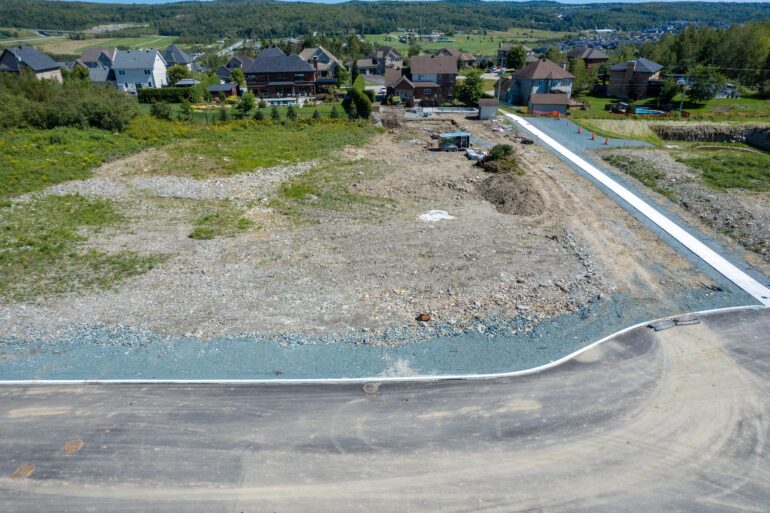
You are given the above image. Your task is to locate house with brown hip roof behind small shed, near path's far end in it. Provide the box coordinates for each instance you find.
[498,59,575,105]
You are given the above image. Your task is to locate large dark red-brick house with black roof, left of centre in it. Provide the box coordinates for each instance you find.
[244,48,316,97]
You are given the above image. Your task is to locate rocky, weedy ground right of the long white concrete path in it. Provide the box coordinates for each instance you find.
[603,149,770,274]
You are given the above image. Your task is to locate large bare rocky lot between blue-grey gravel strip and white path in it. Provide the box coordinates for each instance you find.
[0,116,711,343]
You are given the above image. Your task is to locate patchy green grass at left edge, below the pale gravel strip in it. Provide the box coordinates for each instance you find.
[0,196,164,300]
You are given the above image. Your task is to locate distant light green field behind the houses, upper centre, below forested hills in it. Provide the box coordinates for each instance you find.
[366,29,574,55]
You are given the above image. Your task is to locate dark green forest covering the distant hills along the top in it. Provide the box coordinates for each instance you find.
[0,0,770,43]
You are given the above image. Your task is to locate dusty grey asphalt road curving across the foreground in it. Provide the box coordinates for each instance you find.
[0,309,770,513]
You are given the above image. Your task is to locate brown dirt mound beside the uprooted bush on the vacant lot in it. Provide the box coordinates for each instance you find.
[479,173,545,216]
